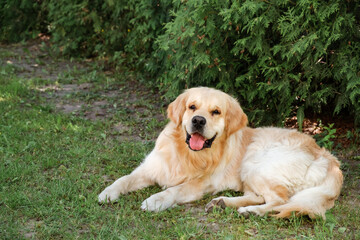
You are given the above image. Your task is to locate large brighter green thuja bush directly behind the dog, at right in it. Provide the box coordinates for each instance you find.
[158,0,360,124]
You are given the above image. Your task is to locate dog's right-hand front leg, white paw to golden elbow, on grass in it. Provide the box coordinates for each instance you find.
[141,179,209,212]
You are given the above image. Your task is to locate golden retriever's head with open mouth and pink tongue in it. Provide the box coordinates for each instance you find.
[168,87,247,151]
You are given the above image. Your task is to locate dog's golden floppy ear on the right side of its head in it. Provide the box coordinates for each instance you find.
[226,97,248,136]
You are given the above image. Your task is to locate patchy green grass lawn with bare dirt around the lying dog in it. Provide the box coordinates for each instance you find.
[0,41,360,239]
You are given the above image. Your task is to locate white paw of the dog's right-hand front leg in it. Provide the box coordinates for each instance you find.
[141,192,174,212]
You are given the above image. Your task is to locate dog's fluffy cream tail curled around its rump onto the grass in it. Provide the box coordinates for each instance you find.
[273,152,343,219]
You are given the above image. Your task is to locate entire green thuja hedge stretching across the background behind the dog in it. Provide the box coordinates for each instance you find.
[0,0,360,125]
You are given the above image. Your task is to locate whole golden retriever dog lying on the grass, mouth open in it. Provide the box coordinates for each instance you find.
[98,87,343,218]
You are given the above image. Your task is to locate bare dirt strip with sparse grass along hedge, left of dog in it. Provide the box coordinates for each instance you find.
[0,40,166,141]
